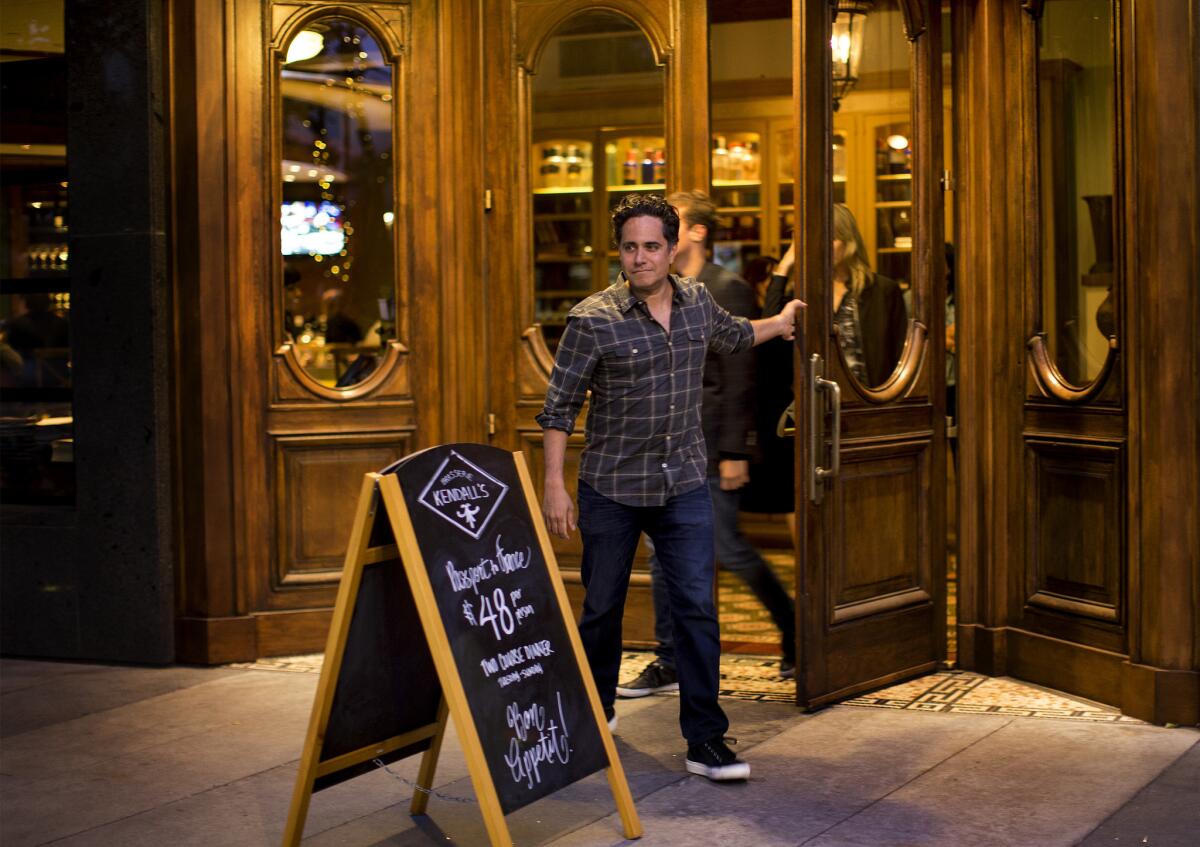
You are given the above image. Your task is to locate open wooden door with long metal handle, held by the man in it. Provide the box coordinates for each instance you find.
[796,2,946,707]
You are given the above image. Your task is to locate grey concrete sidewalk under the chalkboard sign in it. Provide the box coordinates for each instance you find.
[0,660,1200,847]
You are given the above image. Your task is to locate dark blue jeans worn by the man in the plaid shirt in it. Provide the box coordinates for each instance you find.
[580,480,730,744]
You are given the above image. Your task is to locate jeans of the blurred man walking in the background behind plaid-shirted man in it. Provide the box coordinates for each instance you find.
[650,476,796,667]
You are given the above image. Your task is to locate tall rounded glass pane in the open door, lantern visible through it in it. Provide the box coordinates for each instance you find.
[830,0,913,388]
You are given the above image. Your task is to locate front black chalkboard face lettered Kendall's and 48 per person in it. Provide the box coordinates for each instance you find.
[388,444,608,813]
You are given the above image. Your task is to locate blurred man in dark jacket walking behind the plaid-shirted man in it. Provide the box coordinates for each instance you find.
[617,191,796,697]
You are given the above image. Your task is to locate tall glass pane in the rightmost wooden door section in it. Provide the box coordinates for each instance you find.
[1038,0,1116,386]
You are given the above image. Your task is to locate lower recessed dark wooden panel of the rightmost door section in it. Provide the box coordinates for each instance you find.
[1026,438,1124,623]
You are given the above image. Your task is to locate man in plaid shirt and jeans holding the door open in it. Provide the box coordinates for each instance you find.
[538,194,804,780]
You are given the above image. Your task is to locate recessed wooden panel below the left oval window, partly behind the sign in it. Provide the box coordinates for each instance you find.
[272,432,412,589]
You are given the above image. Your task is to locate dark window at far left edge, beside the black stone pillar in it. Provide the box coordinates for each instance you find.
[0,2,74,505]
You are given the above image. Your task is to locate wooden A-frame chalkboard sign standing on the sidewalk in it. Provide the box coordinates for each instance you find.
[283,444,642,847]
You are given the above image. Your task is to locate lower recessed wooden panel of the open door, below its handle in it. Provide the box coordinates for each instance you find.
[828,440,930,624]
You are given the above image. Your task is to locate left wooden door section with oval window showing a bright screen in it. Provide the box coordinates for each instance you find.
[172,0,486,662]
